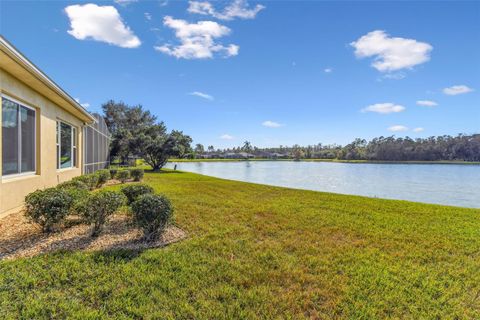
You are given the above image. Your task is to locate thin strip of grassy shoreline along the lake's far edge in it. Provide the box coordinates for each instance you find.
[168,158,480,165]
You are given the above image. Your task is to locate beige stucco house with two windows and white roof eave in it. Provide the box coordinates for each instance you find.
[0,36,97,216]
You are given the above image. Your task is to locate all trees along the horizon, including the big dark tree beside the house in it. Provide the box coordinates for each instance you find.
[102,100,480,164]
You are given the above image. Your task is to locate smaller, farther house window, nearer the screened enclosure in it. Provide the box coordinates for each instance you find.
[57,121,77,169]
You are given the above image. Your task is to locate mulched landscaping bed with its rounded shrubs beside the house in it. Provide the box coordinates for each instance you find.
[0,169,185,259]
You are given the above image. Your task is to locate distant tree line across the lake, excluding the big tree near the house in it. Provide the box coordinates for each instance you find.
[195,134,480,161]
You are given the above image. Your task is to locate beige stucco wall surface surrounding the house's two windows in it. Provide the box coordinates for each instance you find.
[0,69,83,216]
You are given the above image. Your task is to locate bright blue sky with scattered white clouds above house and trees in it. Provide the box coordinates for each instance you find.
[0,0,480,148]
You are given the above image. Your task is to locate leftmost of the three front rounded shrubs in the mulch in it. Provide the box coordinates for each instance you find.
[24,188,73,232]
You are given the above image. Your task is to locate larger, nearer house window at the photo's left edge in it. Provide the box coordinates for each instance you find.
[2,97,36,176]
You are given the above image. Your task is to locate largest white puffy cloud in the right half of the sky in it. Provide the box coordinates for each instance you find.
[350,30,433,72]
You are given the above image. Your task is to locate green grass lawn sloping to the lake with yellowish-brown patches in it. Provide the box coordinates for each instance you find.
[0,172,480,319]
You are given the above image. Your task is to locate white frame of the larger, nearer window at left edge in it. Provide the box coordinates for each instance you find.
[0,94,38,180]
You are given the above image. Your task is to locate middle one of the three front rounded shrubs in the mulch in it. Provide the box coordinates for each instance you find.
[75,190,126,237]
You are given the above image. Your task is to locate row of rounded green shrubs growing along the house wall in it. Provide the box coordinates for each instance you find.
[25,169,173,241]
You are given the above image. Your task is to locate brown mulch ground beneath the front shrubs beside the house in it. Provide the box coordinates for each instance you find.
[0,212,186,260]
